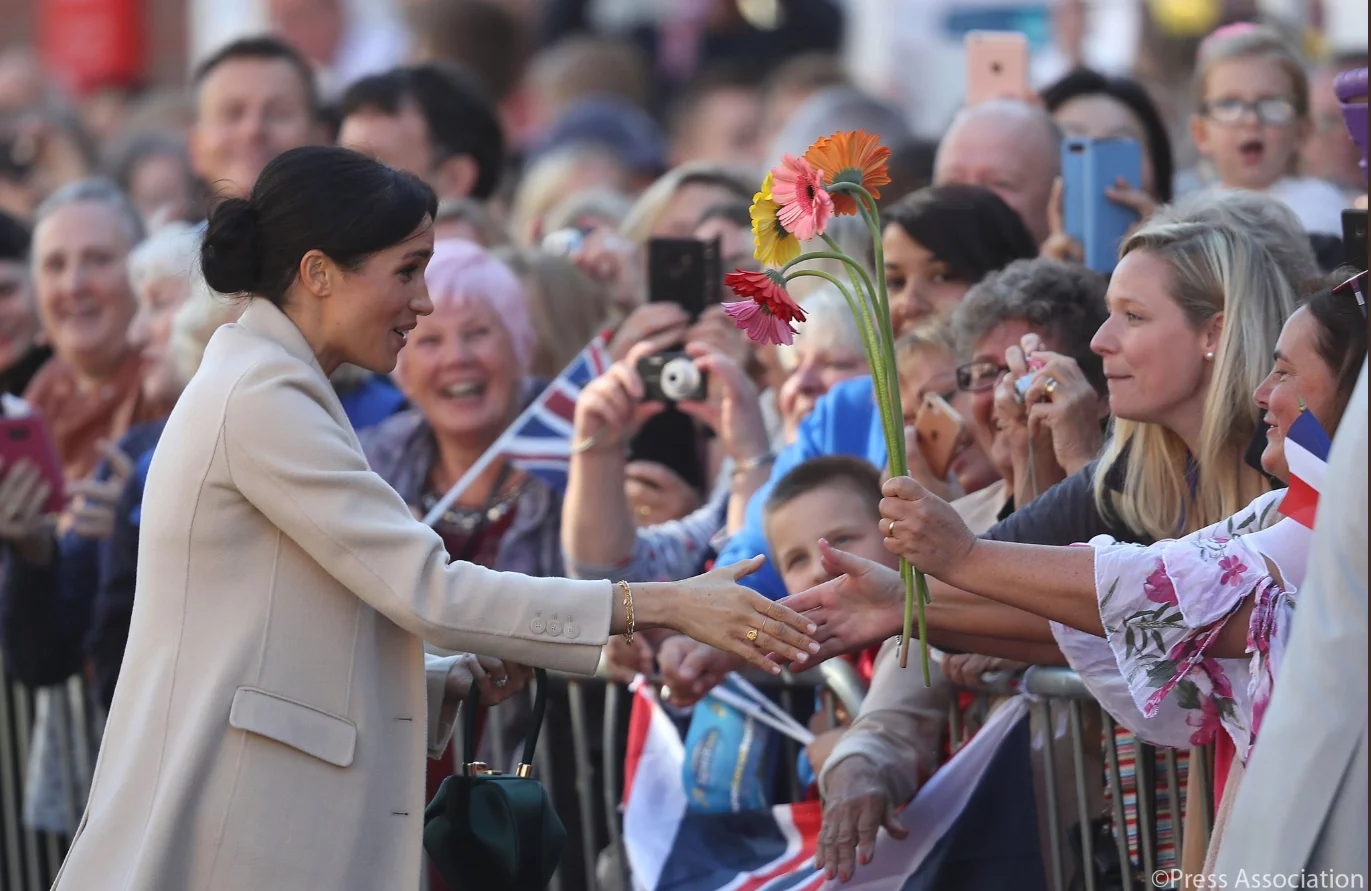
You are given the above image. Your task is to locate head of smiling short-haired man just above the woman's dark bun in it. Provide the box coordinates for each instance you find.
[189,37,324,196]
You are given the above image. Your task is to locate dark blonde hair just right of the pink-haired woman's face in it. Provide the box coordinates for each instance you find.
[491,247,621,378]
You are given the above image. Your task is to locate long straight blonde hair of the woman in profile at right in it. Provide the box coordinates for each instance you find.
[1094,192,1304,539]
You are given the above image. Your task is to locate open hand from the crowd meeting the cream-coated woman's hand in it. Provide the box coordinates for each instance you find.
[780,540,905,672]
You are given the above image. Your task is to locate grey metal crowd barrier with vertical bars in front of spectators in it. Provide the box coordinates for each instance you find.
[0,659,1213,891]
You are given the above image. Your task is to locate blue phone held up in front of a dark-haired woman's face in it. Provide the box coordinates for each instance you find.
[1061,137,1142,274]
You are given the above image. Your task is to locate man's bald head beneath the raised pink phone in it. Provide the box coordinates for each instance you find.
[934,99,1061,244]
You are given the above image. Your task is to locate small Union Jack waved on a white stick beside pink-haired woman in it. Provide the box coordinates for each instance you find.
[492,330,613,492]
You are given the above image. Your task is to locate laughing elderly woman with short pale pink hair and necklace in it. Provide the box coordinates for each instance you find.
[362,240,548,576]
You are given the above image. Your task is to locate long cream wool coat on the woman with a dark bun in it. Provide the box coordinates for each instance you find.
[55,300,613,891]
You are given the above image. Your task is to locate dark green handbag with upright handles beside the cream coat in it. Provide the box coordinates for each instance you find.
[424,669,566,891]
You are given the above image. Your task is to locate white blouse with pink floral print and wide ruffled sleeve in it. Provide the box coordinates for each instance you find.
[1053,489,1309,761]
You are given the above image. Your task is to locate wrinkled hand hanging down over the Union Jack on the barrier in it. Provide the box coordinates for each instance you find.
[814,755,909,881]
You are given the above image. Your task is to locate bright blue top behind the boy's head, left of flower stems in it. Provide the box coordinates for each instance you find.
[717,377,886,600]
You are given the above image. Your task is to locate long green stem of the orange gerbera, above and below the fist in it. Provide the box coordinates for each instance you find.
[817,182,932,687]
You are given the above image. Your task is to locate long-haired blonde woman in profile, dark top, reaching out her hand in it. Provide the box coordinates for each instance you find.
[786,193,1313,882]
